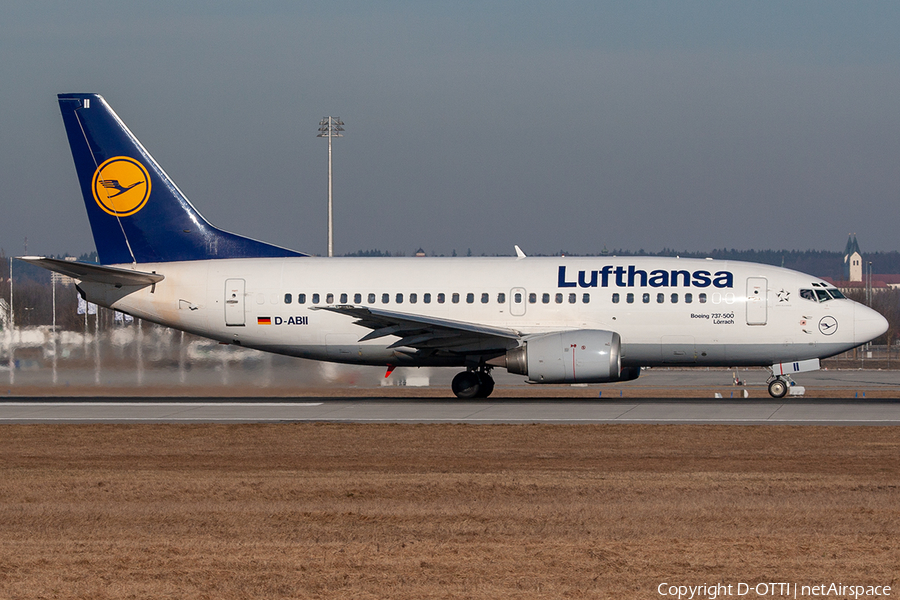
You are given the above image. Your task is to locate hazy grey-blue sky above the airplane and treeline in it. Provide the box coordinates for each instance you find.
[0,0,900,254]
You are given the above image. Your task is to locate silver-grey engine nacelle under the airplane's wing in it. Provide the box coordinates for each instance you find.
[506,329,624,383]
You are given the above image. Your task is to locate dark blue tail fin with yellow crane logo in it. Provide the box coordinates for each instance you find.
[59,94,306,264]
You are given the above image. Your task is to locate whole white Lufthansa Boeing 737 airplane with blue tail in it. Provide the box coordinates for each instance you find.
[22,94,888,399]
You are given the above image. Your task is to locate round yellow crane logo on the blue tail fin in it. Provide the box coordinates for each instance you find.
[93,156,150,217]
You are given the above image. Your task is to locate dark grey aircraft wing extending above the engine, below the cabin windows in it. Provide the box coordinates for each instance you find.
[316,305,522,354]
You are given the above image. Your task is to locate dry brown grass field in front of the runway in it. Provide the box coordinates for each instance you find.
[0,424,900,600]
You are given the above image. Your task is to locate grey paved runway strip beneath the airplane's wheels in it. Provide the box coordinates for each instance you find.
[0,398,900,425]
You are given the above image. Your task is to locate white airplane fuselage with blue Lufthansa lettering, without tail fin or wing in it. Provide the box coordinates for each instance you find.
[80,257,885,366]
